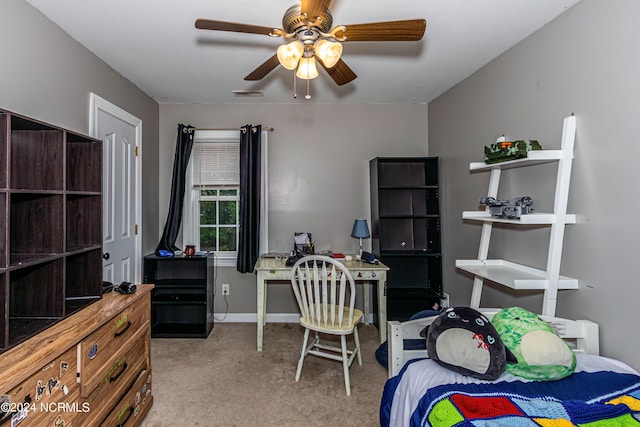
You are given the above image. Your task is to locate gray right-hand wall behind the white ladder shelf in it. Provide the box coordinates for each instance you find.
[429,0,640,369]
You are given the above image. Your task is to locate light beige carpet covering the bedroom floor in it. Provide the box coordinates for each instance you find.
[142,323,387,427]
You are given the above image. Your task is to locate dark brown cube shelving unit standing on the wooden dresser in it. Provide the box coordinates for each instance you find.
[0,110,102,352]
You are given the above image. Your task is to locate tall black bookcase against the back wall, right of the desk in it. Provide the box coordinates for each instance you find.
[369,157,443,321]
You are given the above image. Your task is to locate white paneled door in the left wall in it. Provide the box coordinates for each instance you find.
[91,94,141,284]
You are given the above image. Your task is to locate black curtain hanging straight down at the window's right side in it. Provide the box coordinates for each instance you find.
[237,125,262,273]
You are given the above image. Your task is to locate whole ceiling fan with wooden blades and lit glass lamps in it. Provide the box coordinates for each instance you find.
[195,0,427,86]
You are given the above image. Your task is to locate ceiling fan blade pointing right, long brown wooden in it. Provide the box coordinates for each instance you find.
[336,19,427,42]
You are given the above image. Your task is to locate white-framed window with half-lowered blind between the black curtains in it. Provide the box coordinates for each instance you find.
[183,130,268,266]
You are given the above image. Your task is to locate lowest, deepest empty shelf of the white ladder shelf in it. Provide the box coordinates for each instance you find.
[456,259,579,290]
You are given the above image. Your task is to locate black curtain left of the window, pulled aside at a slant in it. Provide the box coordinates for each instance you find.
[156,124,195,254]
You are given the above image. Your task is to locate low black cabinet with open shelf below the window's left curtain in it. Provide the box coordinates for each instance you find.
[144,255,214,338]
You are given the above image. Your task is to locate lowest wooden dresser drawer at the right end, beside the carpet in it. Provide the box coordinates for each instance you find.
[101,369,153,427]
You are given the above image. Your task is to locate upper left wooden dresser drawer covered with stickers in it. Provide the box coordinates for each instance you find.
[3,347,83,427]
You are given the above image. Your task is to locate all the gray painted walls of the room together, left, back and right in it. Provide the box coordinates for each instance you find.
[7,0,640,368]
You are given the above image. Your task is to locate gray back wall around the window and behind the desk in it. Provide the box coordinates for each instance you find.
[159,102,427,313]
